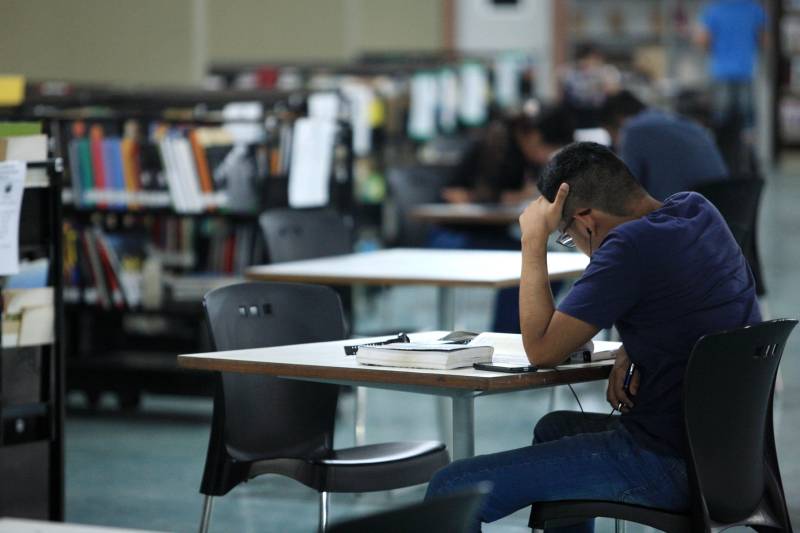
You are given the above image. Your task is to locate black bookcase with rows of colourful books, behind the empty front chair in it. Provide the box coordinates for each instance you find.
[10,85,352,408]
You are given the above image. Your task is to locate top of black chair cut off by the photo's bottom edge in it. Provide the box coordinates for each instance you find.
[329,485,488,533]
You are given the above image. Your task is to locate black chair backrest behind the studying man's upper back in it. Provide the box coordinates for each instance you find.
[695,176,766,296]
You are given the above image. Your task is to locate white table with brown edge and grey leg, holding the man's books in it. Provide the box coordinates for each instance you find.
[178,331,619,459]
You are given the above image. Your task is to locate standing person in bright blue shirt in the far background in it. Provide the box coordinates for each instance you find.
[695,0,767,168]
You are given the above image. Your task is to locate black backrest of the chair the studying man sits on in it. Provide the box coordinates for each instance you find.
[684,320,797,523]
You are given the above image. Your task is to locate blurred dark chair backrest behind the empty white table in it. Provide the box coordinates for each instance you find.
[259,208,353,263]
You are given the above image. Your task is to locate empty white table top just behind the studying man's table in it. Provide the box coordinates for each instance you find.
[245,248,589,288]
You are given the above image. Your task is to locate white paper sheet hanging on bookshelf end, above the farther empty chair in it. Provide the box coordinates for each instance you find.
[289,117,336,207]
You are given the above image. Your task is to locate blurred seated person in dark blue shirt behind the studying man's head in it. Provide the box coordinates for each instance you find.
[602,90,728,201]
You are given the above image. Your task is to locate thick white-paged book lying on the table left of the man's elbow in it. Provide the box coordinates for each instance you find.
[356,342,494,370]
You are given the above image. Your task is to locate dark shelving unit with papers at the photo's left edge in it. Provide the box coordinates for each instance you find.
[0,158,64,521]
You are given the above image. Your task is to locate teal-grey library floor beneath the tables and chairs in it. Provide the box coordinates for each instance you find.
[66,173,800,533]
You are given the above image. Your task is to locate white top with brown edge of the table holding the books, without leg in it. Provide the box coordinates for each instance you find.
[178,331,618,391]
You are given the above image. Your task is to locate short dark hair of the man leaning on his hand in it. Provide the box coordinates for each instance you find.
[538,142,646,220]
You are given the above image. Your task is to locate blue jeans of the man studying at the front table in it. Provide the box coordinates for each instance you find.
[426,411,689,532]
